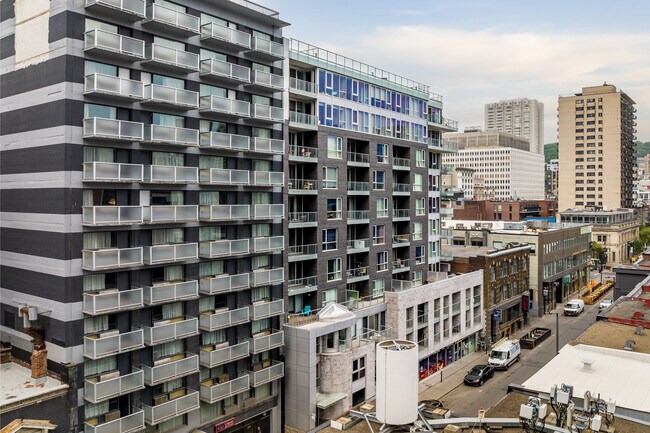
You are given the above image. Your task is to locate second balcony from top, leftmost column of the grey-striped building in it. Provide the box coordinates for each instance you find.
[84,29,144,61]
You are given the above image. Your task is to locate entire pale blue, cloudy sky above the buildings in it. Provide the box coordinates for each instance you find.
[254,0,650,143]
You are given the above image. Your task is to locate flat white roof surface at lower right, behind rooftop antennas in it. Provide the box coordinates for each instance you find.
[523,344,650,413]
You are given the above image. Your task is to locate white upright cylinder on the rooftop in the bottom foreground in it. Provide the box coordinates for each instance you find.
[375,340,419,425]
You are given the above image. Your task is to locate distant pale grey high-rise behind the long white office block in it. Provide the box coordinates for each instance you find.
[485,98,544,155]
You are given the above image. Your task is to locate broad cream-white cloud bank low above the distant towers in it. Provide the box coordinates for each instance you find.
[323,25,650,142]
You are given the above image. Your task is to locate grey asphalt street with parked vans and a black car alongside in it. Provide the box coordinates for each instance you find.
[420,294,611,416]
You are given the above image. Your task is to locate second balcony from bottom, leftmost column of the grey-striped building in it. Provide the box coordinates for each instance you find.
[84,368,144,403]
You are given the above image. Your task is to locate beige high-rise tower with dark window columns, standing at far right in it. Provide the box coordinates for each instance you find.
[558,84,636,211]
